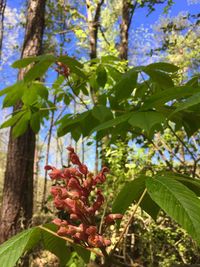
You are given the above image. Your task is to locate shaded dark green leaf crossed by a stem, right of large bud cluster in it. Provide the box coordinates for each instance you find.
[112,175,159,219]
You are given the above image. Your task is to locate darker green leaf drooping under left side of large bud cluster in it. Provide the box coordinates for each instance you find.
[40,223,71,267]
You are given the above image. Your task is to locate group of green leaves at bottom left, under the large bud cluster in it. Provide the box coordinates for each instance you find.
[0,224,90,267]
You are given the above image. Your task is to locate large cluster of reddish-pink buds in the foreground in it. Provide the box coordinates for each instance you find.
[45,147,122,248]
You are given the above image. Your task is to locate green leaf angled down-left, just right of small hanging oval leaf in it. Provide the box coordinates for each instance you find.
[112,69,138,99]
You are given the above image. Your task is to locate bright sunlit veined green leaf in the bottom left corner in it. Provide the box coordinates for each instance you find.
[0,227,41,267]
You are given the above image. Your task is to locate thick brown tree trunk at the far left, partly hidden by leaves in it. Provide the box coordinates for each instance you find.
[0,0,45,243]
